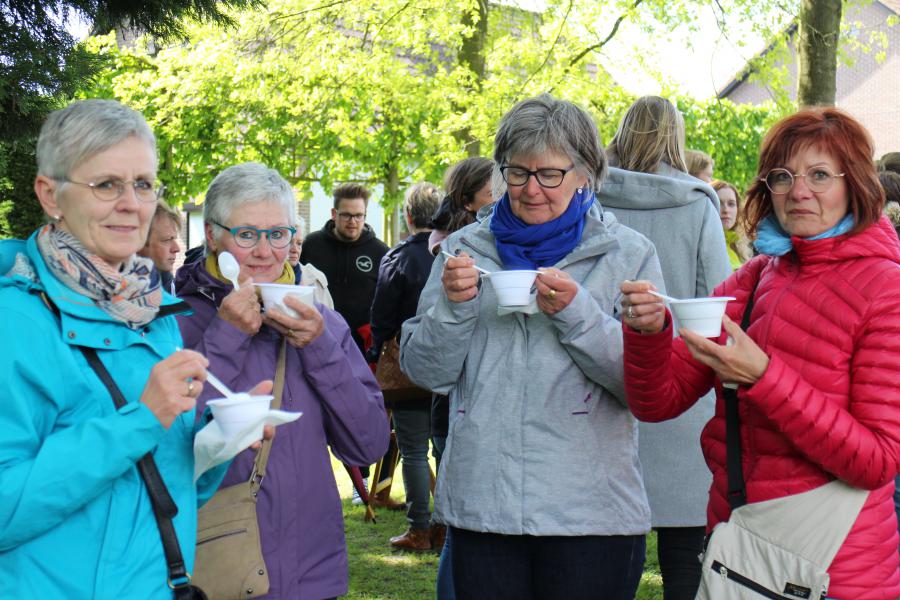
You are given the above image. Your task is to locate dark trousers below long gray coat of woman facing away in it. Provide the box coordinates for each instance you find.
[656,527,706,600]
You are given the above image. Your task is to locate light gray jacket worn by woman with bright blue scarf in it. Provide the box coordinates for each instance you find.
[400,205,662,535]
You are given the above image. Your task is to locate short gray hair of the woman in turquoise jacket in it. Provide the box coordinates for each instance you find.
[37,100,156,181]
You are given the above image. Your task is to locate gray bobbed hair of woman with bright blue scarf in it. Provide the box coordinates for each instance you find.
[494,94,607,190]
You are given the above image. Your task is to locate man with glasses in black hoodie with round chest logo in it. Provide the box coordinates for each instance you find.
[300,183,388,353]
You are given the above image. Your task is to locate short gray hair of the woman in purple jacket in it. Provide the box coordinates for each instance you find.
[203,162,297,250]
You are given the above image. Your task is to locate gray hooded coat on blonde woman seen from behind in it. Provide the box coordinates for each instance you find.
[599,163,731,527]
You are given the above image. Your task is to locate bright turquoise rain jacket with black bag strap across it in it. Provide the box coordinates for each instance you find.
[0,235,228,600]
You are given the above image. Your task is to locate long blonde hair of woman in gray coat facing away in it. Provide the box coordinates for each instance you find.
[607,96,687,173]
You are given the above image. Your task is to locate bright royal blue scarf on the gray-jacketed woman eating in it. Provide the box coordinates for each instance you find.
[491,189,596,269]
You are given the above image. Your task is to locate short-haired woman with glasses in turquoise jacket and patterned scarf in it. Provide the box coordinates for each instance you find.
[0,100,271,600]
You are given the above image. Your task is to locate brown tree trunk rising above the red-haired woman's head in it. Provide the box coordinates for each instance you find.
[797,0,842,107]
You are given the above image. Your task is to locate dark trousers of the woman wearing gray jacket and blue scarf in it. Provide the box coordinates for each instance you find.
[450,527,646,600]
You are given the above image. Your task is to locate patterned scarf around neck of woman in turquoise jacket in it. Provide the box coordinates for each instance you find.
[37,224,162,329]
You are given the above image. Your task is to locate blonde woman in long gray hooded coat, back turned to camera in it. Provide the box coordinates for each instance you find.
[599,96,731,600]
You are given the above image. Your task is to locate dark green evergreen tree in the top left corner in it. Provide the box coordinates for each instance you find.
[0,0,258,237]
